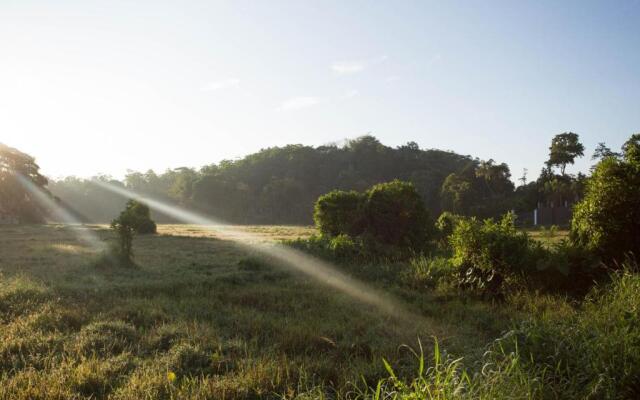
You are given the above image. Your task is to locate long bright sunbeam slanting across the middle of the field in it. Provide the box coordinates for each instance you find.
[93,180,426,323]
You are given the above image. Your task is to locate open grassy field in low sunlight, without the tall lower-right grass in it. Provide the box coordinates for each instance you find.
[0,225,536,399]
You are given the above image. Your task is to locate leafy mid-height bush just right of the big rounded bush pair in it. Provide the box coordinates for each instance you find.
[450,213,544,294]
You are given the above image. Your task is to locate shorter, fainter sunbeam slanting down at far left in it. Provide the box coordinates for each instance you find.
[16,174,106,251]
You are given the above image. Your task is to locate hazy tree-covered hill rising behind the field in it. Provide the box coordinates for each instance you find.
[49,136,488,224]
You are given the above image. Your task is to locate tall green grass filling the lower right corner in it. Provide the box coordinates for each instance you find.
[292,267,640,400]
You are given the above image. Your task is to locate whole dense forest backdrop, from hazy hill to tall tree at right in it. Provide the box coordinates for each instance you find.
[43,134,584,224]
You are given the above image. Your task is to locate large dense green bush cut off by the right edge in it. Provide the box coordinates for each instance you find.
[571,134,640,259]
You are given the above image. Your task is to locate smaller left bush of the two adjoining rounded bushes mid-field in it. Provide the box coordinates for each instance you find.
[313,190,365,236]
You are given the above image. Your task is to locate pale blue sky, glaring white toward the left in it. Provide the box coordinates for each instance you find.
[0,0,640,179]
